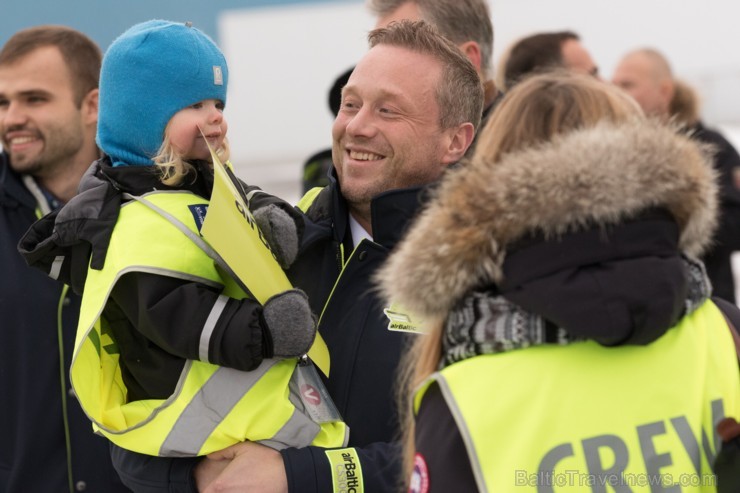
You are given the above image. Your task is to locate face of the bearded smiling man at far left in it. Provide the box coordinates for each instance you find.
[0,29,98,202]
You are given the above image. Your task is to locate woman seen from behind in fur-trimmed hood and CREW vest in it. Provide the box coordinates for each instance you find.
[378,74,740,491]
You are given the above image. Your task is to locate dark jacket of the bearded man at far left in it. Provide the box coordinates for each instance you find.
[0,154,128,493]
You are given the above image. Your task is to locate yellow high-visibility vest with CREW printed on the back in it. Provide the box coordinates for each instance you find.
[415,301,740,493]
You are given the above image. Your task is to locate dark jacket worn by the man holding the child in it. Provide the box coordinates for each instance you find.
[283,171,426,493]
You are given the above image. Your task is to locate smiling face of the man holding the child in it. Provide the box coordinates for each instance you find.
[332,38,477,234]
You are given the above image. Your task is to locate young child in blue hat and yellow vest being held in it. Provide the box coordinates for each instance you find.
[21,20,347,456]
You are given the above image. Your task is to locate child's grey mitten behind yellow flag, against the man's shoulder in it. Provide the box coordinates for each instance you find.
[252,204,303,269]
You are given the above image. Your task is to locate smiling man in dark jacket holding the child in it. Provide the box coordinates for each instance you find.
[176,21,483,493]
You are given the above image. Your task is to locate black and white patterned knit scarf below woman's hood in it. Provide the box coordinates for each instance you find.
[440,256,711,368]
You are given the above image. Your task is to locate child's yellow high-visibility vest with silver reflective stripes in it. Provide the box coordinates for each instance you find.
[71,192,348,456]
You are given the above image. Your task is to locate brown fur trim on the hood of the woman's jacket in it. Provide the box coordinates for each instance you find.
[376,120,717,317]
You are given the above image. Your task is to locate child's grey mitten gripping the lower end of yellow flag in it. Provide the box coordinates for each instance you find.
[262,289,316,358]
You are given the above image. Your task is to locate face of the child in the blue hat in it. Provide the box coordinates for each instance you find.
[167,99,228,161]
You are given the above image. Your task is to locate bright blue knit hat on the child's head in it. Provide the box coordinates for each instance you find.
[96,20,229,166]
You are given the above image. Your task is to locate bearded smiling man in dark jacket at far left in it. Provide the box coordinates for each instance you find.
[0,26,125,492]
